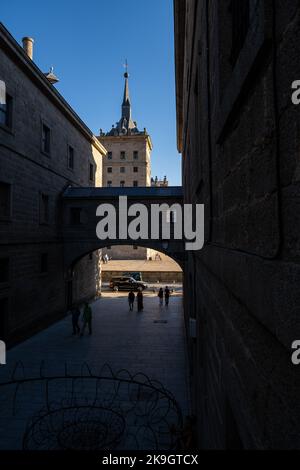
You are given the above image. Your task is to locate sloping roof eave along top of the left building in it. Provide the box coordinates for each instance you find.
[0,22,107,155]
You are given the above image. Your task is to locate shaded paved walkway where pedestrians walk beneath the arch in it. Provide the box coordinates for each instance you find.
[0,292,189,449]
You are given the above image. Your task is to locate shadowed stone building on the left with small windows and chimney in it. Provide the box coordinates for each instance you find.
[0,24,106,344]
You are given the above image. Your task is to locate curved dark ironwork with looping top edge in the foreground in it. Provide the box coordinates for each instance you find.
[0,362,183,451]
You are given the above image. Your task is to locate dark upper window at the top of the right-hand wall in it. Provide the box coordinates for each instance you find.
[230,0,250,66]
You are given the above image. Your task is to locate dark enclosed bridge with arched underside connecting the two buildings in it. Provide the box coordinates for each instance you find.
[62,187,184,270]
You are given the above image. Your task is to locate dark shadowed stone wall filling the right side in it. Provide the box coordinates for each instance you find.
[174,0,300,449]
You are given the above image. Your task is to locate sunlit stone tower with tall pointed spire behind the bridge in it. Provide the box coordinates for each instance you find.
[98,72,153,259]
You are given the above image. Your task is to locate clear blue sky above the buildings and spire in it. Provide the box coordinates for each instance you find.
[0,0,181,185]
